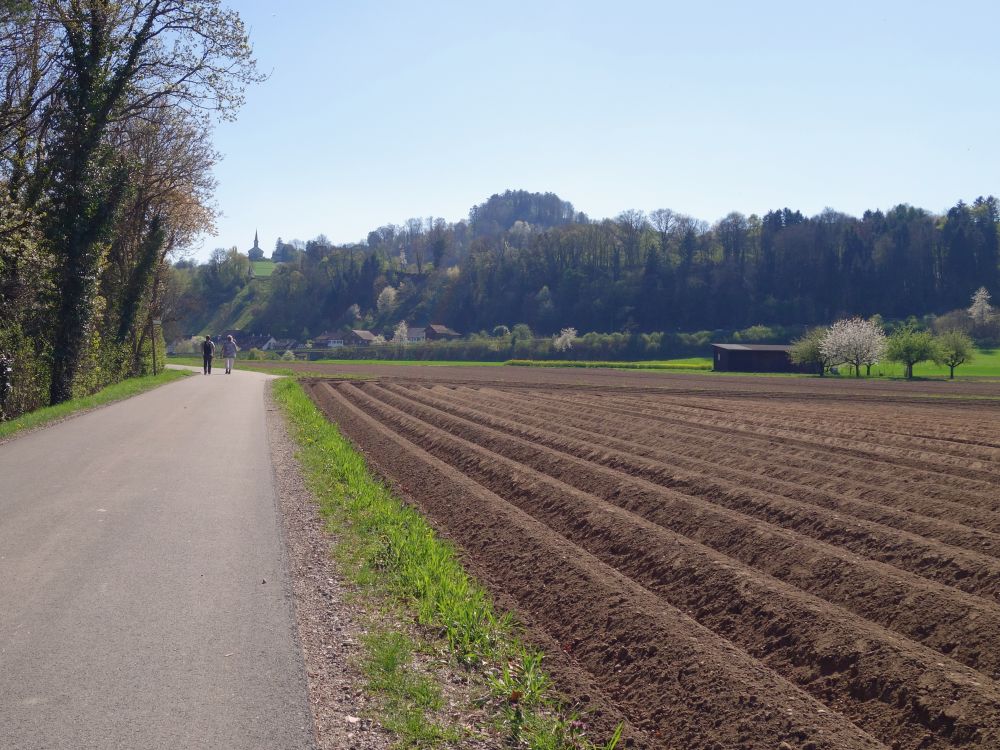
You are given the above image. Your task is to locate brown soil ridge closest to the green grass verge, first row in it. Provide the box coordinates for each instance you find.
[312,387,886,750]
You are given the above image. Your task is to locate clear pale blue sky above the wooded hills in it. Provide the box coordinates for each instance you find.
[197,0,1000,258]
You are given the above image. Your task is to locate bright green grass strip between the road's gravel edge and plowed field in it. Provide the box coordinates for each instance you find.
[274,379,621,750]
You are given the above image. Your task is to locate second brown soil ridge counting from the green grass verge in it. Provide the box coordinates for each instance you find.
[334,386,1000,748]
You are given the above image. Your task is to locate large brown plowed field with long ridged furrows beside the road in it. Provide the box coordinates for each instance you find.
[306,372,1000,750]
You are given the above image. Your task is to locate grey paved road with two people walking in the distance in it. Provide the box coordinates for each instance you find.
[0,370,312,750]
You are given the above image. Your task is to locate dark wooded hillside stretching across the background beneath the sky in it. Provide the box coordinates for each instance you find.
[169,191,1000,354]
